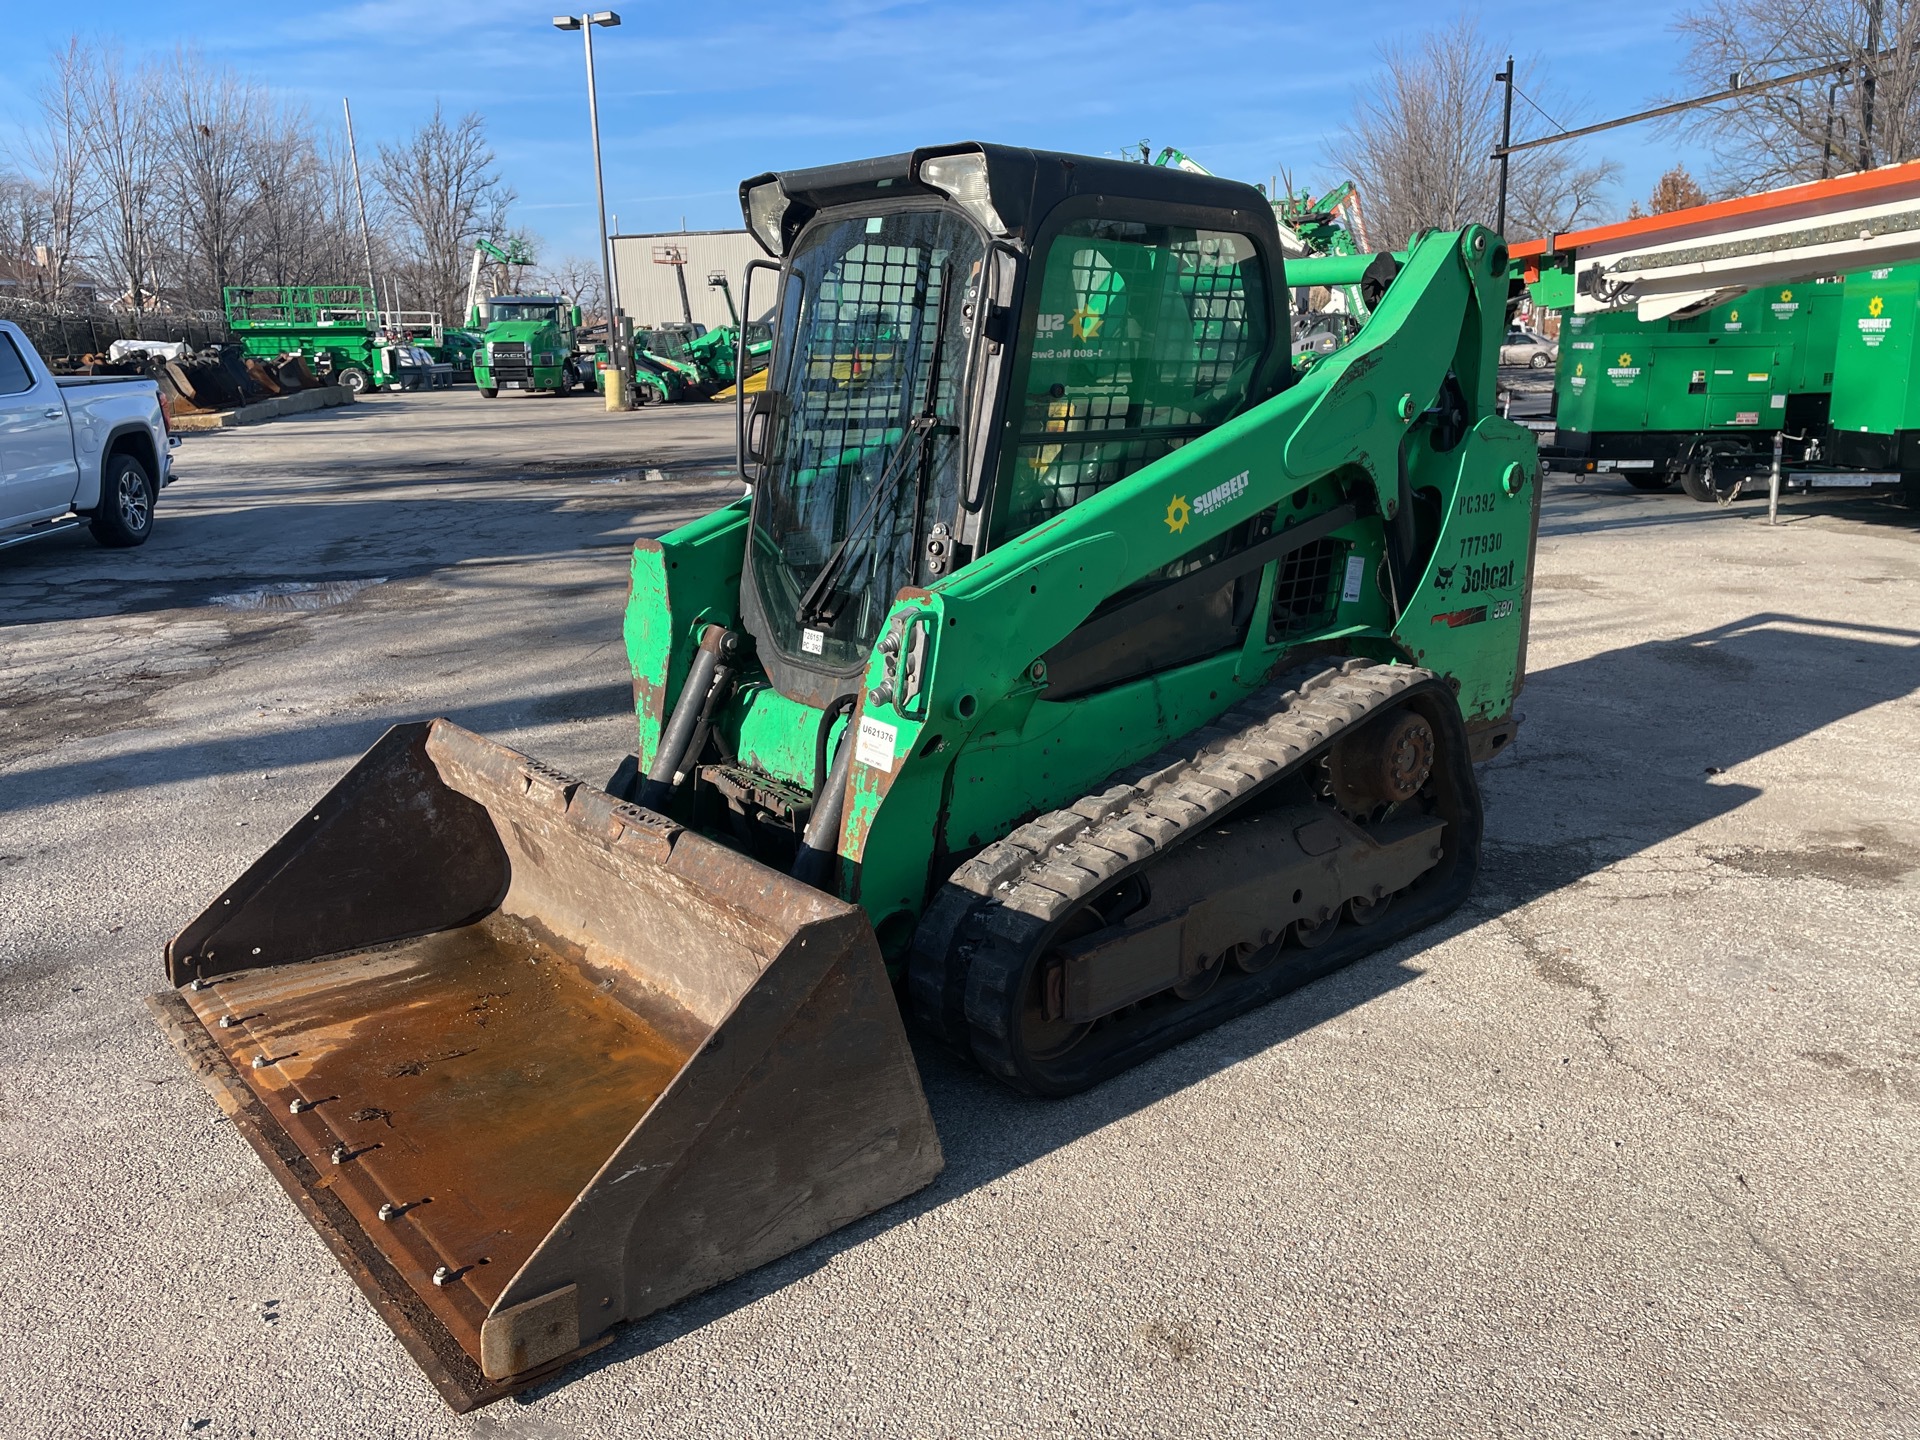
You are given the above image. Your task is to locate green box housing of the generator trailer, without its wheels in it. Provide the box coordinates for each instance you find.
[1555,282,1841,434]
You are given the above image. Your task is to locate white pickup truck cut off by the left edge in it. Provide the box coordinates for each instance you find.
[0,321,173,549]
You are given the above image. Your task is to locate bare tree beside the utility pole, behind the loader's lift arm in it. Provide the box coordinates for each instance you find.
[1331,15,1619,250]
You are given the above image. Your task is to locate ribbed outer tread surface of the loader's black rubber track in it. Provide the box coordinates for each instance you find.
[908,660,1434,1091]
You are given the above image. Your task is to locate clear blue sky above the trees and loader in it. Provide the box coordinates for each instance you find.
[0,0,1707,257]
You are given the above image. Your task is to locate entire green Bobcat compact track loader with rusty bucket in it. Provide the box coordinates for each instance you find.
[156,144,1538,1409]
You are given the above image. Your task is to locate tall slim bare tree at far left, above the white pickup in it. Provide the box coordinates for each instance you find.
[79,50,159,311]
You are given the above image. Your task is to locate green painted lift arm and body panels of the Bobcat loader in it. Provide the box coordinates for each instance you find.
[626,230,1538,958]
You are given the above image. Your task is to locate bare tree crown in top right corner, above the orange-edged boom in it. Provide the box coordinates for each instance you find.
[1674,0,1920,194]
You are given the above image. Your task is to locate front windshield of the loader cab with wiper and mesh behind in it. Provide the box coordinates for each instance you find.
[753,209,985,668]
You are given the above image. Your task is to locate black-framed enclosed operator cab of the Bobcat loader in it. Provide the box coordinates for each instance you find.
[741,144,1294,707]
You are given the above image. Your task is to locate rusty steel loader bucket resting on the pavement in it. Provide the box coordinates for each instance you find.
[156,720,943,1409]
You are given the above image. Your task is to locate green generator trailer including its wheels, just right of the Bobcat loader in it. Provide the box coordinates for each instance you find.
[1549,278,1843,499]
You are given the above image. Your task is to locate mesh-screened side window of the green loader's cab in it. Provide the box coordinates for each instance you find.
[993,219,1267,543]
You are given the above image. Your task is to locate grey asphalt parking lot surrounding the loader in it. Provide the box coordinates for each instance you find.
[0,392,1920,1440]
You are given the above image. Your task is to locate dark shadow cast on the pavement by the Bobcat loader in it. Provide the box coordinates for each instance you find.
[522,614,1920,1400]
